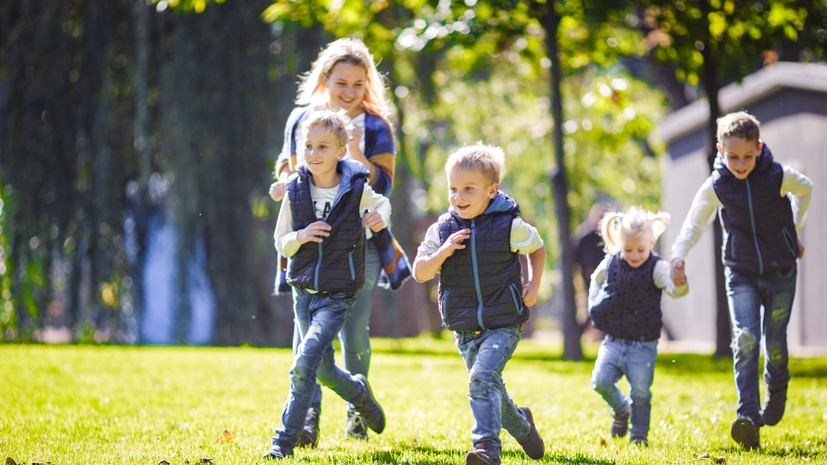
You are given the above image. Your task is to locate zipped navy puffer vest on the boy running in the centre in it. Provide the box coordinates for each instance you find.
[438,192,529,331]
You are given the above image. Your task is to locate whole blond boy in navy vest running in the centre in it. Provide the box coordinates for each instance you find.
[413,144,545,465]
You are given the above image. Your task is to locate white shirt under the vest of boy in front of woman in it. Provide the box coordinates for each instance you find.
[273,183,391,257]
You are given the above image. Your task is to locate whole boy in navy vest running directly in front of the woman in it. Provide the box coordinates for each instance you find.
[264,110,390,459]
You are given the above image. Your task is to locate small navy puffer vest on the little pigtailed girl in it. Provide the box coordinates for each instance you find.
[589,252,663,341]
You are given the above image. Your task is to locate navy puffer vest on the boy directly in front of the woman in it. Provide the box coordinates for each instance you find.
[287,160,368,292]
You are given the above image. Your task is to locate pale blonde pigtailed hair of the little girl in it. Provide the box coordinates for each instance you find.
[600,207,671,253]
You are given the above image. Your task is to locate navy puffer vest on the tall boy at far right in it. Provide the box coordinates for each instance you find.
[712,144,798,276]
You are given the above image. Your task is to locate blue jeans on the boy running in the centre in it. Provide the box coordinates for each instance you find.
[454,326,531,455]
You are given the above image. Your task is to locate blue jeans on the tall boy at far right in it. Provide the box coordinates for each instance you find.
[726,265,797,424]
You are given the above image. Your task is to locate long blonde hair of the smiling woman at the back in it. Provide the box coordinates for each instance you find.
[296,38,390,118]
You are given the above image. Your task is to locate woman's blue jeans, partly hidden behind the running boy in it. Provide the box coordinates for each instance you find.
[293,240,382,411]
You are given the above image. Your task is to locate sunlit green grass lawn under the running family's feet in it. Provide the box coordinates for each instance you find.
[0,338,827,465]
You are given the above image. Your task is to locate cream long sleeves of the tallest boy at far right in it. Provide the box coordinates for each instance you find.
[672,166,813,260]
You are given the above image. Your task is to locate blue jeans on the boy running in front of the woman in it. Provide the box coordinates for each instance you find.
[273,288,364,450]
